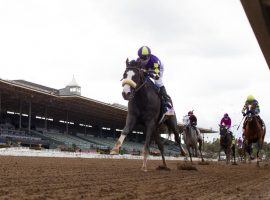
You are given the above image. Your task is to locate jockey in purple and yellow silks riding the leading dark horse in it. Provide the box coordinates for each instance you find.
[137,46,174,115]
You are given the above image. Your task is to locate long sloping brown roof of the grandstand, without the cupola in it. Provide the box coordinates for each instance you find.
[0,79,214,133]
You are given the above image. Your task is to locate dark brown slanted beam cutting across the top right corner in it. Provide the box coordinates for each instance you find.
[241,0,270,69]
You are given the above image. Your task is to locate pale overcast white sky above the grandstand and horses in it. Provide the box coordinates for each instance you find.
[0,0,270,141]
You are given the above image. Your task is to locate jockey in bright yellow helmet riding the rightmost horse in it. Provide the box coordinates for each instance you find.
[242,95,264,129]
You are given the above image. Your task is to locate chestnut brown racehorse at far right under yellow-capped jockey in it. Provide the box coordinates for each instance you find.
[243,109,266,166]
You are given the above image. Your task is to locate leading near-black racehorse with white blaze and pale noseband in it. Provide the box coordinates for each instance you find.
[111,59,184,171]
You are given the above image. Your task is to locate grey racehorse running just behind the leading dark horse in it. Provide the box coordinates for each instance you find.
[183,125,204,162]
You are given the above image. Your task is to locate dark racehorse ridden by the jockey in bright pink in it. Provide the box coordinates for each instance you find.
[218,124,232,164]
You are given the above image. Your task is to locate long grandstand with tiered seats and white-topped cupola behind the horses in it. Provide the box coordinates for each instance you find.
[0,77,213,155]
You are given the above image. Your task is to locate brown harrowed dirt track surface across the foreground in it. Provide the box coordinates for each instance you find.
[0,156,270,200]
